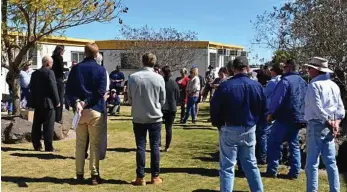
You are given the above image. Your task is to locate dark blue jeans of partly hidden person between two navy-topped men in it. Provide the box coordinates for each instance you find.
[256,124,271,163]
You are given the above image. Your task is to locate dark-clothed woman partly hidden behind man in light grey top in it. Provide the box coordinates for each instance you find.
[162,66,179,152]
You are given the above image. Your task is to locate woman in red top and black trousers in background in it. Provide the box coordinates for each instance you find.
[176,68,189,123]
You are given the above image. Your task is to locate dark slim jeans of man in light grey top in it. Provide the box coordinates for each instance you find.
[134,122,161,178]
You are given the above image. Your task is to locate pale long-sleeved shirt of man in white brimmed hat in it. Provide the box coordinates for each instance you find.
[305,74,345,123]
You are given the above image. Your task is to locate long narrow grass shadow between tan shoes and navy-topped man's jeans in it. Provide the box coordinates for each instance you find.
[145,167,219,177]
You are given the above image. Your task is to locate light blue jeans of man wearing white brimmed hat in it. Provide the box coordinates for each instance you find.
[305,120,340,192]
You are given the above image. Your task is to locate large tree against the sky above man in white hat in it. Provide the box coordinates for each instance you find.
[254,0,347,104]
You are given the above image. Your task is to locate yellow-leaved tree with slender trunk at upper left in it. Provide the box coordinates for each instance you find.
[1,0,128,115]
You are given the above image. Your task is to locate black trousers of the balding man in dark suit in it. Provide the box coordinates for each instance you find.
[31,108,55,151]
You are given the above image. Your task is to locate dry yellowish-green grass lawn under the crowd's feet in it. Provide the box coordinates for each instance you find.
[1,104,347,192]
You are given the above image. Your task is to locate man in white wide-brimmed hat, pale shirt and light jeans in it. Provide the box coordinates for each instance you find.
[305,57,345,192]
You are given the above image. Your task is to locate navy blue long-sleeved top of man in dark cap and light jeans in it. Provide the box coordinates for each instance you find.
[210,74,267,127]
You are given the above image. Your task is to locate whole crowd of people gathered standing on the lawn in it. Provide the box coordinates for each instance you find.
[2,43,345,191]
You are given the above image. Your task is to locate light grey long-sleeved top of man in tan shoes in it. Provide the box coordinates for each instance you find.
[128,67,166,124]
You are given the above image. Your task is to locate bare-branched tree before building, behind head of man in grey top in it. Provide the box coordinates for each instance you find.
[116,25,197,71]
